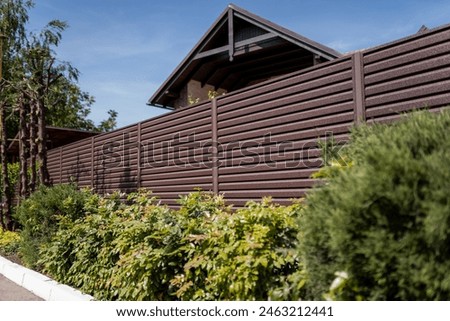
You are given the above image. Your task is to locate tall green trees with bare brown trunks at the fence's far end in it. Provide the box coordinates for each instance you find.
[0,0,117,228]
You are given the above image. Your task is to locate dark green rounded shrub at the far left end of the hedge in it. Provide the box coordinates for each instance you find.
[15,184,90,269]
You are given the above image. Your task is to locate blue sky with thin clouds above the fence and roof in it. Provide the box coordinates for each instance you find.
[29,0,450,127]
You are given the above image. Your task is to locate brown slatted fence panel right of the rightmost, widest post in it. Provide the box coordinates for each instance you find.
[364,26,450,121]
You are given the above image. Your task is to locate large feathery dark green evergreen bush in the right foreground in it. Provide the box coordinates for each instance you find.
[299,111,450,300]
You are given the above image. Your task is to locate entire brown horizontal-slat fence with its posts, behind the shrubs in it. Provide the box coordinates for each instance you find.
[48,25,450,205]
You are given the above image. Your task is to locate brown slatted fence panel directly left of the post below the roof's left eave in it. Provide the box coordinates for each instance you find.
[140,102,212,205]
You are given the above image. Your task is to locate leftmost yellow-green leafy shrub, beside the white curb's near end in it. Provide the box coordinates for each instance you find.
[39,190,124,299]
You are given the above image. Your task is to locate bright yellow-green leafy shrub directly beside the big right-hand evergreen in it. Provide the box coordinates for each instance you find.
[172,199,300,300]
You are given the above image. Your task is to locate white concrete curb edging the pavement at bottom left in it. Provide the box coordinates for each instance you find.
[0,256,94,301]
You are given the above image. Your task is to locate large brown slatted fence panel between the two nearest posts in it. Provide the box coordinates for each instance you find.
[217,57,354,205]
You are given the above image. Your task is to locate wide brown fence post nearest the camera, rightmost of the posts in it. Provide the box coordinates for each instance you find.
[352,51,366,125]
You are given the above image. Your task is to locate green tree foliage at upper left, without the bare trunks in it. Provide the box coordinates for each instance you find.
[0,0,117,137]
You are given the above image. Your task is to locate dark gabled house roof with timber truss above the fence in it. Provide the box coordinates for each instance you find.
[148,4,341,107]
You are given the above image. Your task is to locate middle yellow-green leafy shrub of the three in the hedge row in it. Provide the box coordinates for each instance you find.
[108,191,225,300]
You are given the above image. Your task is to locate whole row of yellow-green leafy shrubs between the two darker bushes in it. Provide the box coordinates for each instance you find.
[41,191,300,300]
